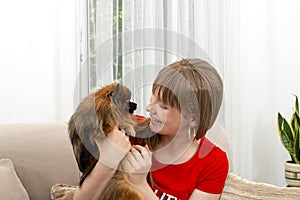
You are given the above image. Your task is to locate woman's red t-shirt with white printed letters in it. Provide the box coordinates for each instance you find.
[150,137,228,200]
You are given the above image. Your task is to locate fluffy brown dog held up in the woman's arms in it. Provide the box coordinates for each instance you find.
[68,84,151,200]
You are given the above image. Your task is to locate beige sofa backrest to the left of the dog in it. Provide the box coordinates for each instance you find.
[0,123,80,200]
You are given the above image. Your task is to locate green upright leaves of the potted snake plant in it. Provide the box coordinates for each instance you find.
[277,95,300,164]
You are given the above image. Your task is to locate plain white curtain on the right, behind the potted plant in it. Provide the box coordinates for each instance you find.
[223,0,300,186]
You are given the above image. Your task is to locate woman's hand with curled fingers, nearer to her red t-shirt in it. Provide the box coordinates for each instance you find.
[121,145,152,184]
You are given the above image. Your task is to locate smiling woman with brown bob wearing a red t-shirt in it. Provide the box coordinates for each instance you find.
[121,59,228,200]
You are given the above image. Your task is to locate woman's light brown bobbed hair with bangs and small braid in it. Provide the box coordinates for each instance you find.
[152,58,223,142]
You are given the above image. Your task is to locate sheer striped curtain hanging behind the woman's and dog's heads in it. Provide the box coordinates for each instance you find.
[83,0,223,115]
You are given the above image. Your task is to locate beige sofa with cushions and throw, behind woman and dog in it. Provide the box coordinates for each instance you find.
[0,123,300,200]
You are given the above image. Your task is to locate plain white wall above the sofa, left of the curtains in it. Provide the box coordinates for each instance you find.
[0,0,76,123]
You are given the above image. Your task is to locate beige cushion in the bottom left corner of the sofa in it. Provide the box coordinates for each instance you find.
[0,159,29,200]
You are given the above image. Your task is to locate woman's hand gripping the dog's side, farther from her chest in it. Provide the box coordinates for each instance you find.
[95,126,131,169]
